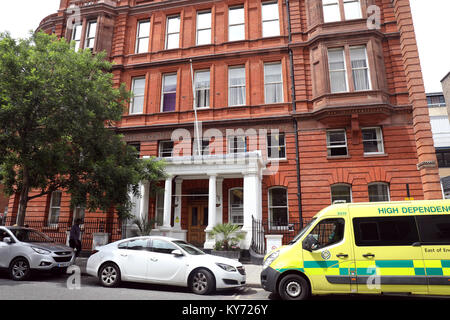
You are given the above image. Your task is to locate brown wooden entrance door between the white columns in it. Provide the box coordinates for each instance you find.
[187,202,208,248]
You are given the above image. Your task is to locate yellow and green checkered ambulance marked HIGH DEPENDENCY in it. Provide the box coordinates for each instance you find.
[261,200,450,300]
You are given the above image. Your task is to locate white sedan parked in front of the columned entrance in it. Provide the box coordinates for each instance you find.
[86,236,246,294]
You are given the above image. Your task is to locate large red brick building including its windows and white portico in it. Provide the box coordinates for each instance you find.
[9,0,442,248]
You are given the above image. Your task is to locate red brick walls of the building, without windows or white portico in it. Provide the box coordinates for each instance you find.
[10,0,441,245]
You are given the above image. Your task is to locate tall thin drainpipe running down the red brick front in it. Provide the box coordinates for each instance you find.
[286,0,303,228]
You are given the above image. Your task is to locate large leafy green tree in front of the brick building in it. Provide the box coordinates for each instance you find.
[0,33,164,225]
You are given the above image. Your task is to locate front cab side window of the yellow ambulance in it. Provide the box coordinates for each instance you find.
[309,219,345,250]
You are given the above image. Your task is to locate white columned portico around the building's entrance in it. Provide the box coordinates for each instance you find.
[140,151,265,249]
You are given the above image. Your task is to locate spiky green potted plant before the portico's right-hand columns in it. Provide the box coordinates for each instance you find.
[210,223,245,260]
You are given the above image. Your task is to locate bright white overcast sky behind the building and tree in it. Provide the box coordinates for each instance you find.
[0,0,450,92]
